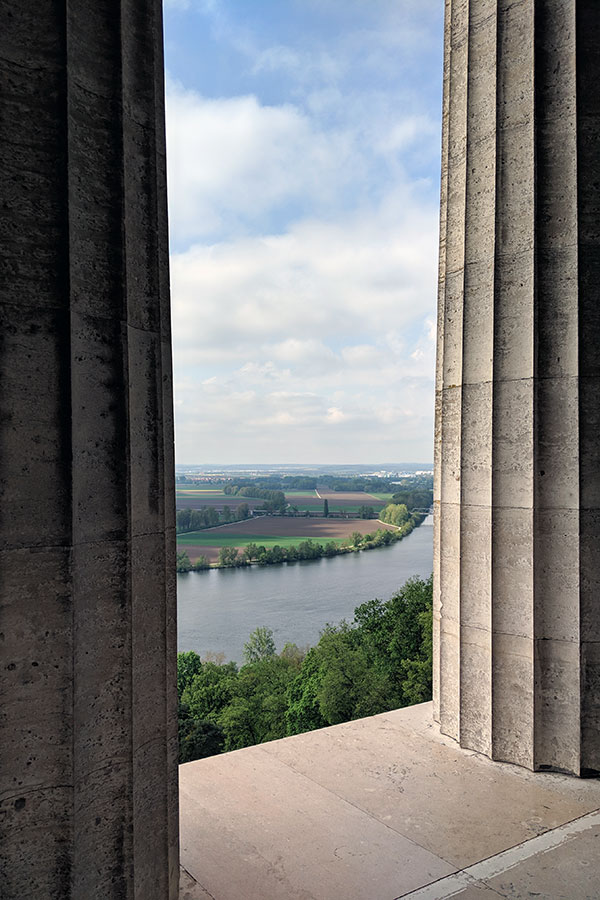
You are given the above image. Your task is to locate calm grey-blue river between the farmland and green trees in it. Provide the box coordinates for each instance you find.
[177,516,433,663]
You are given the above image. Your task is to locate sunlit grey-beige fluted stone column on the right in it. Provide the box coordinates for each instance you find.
[434,0,600,774]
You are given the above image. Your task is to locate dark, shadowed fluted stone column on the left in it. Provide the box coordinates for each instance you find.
[0,0,178,900]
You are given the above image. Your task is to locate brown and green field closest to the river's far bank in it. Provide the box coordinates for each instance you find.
[177,516,395,562]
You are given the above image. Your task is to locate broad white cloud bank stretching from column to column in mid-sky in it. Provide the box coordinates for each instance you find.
[171,196,437,367]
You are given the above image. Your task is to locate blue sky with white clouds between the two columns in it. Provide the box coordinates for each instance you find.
[165,0,443,464]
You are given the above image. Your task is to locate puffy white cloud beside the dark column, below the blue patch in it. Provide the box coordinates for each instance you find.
[167,82,360,244]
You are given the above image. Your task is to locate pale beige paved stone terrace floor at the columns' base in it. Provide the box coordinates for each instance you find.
[180,703,600,900]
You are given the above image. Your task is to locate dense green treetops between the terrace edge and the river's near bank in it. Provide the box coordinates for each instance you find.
[177,578,432,762]
